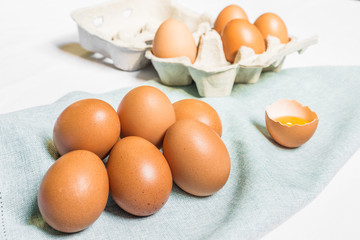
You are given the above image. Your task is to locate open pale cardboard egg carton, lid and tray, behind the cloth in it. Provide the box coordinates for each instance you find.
[71,0,317,97]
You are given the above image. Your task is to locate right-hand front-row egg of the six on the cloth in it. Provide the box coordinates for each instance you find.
[163,119,231,196]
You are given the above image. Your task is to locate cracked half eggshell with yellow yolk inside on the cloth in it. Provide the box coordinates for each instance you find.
[265,99,319,148]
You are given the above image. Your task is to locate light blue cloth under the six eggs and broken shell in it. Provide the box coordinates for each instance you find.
[0,66,360,239]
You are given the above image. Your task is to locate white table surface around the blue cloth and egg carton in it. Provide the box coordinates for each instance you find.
[0,0,360,240]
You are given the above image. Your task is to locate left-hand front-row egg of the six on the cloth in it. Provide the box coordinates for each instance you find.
[38,150,109,233]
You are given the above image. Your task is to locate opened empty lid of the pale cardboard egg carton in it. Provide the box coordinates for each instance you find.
[71,0,212,71]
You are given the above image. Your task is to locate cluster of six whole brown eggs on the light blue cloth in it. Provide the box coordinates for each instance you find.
[38,86,231,232]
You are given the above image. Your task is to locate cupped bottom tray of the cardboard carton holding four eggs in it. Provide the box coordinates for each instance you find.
[145,30,318,97]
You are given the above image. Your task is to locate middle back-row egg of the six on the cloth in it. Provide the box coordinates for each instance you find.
[117,86,176,147]
